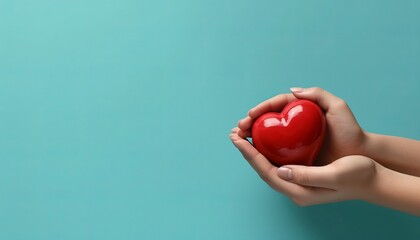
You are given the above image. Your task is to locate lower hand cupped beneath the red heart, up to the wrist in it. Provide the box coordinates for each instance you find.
[230,128,378,206]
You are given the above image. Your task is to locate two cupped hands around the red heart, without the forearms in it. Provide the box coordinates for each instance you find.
[230,88,379,206]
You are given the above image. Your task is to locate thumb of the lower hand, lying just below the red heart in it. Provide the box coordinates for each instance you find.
[277,165,335,189]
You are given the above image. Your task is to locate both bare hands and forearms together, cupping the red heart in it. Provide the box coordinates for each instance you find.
[230,88,420,216]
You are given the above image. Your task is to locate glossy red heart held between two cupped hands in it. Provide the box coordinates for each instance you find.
[252,100,326,166]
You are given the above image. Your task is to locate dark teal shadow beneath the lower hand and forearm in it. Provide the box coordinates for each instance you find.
[267,194,420,240]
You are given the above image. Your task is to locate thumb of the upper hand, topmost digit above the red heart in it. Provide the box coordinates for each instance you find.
[290,87,345,111]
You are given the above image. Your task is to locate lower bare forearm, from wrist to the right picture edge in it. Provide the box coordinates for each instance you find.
[364,164,420,216]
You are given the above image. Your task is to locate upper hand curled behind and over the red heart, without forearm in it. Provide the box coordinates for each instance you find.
[237,87,367,165]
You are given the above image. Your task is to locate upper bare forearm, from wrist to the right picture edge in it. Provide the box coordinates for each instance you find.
[364,133,420,176]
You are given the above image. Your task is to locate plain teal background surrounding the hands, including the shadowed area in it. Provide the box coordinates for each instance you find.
[0,0,420,240]
